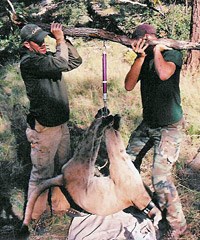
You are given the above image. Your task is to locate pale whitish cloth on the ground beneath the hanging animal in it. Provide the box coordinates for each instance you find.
[67,208,156,240]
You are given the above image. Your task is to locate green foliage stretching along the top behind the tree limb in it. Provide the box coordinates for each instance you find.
[0,0,194,64]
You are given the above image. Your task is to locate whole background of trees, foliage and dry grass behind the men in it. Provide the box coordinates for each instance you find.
[0,0,200,240]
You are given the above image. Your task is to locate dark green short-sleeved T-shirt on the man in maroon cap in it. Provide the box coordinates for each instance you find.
[140,50,183,127]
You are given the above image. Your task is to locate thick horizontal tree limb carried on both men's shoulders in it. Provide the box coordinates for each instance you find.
[38,24,200,50]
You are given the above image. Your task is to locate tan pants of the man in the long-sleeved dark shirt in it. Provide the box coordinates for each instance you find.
[26,121,71,220]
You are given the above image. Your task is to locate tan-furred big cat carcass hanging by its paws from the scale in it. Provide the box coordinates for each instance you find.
[24,117,161,228]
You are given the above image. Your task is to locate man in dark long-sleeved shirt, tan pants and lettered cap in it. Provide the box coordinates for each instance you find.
[20,23,82,232]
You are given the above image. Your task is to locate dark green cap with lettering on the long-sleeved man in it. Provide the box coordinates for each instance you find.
[20,24,49,43]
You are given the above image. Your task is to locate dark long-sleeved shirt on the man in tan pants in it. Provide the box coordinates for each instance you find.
[20,42,82,127]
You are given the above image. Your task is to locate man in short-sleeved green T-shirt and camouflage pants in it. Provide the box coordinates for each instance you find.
[125,24,187,239]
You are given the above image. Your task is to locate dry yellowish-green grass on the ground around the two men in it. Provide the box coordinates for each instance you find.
[0,39,200,240]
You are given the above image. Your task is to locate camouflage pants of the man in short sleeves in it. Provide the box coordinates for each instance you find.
[127,119,186,229]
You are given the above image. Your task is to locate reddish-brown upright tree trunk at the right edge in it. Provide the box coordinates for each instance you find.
[186,0,200,74]
